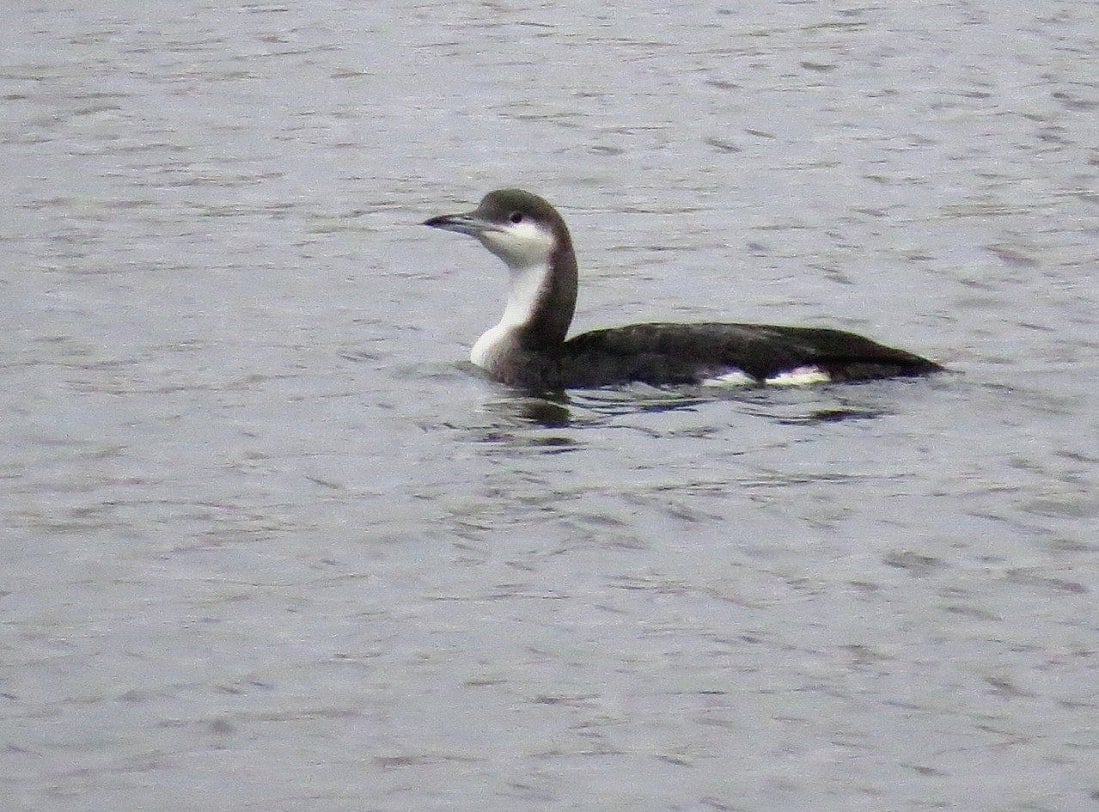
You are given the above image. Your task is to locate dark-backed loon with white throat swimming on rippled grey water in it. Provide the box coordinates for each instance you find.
[423,189,943,391]
